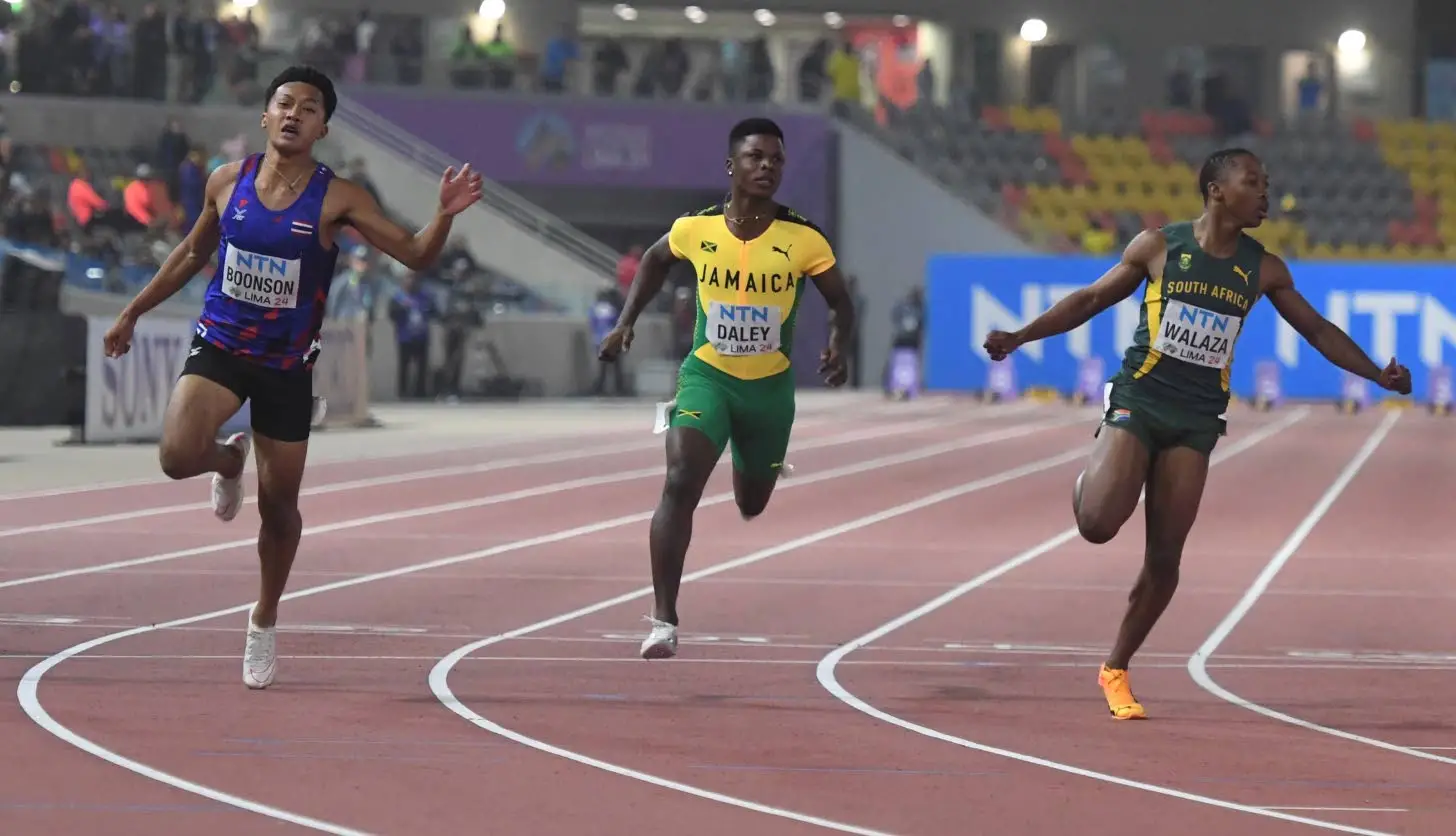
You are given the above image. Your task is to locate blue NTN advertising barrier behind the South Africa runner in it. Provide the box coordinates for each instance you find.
[925,255,1456,401]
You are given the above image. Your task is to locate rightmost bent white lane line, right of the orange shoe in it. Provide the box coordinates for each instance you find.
[1188,411,1456,763]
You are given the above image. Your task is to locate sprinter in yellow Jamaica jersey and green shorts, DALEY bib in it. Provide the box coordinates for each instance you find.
[600,119,855,658]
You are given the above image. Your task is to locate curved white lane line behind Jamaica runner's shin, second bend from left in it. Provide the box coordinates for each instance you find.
[430,447,1086,833]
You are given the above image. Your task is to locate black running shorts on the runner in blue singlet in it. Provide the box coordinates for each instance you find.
[182,336,313,441]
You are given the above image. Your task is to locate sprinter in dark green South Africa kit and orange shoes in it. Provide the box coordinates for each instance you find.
[986,149,1411,719]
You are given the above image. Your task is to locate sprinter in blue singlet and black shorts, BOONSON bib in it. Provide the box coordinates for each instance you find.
[105,67,480,689]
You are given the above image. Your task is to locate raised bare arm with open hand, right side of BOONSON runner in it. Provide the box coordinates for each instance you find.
[333,163,480,269]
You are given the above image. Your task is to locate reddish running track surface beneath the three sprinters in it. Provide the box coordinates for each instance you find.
[0,406,1456,836]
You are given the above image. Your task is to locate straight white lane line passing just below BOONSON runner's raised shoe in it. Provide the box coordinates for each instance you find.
[0,418,1070,590]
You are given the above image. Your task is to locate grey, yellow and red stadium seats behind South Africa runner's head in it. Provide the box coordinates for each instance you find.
[856,105,1432,261]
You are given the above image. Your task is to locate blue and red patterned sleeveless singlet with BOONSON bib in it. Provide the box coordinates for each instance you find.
[197,154,339,370]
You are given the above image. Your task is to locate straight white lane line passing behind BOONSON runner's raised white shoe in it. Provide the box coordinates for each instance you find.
[0,407,1013,537]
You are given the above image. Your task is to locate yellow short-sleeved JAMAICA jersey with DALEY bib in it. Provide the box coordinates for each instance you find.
[667,205,834,380]
